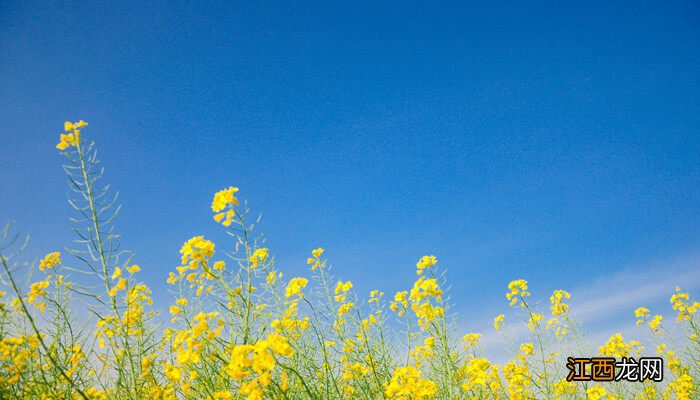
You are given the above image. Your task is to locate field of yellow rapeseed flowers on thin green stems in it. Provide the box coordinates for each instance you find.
[0,121,700,400]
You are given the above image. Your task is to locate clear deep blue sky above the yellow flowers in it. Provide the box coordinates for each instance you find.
[0,1,700,356]
